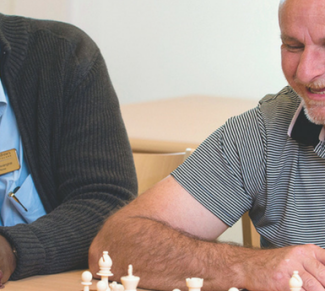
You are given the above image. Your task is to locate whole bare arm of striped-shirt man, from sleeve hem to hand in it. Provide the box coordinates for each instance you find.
[89,178,325,291]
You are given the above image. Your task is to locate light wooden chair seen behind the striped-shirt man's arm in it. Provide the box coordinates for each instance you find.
[133,148,260,247]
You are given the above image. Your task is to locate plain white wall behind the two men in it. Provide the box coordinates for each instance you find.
[0,0,286,103]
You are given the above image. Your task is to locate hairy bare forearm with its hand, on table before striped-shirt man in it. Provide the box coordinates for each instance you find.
[89,213,325,291]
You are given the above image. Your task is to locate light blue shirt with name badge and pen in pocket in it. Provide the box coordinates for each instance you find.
[0,80,46,226]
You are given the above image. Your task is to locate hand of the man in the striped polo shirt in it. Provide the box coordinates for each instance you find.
[242,244,325,291]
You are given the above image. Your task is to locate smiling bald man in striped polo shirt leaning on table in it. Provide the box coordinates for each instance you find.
[89,0,325,291]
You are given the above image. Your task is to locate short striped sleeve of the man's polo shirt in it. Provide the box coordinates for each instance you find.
[172,107,265,226]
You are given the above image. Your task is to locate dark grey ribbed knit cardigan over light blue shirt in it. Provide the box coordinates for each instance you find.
[0,14,137,279]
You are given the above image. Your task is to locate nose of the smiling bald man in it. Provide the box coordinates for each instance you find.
[296,47,325,84]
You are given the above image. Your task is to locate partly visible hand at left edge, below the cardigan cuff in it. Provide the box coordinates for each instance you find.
[0,236,16,286]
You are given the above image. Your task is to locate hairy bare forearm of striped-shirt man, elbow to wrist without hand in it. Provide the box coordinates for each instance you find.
[90,216,248,290]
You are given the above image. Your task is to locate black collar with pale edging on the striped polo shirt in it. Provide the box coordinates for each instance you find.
[288,103,325,147]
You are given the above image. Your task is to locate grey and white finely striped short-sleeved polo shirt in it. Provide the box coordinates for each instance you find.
[172,87,325,248]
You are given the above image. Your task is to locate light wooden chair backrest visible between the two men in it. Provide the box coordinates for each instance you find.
[133,149,194,194]
